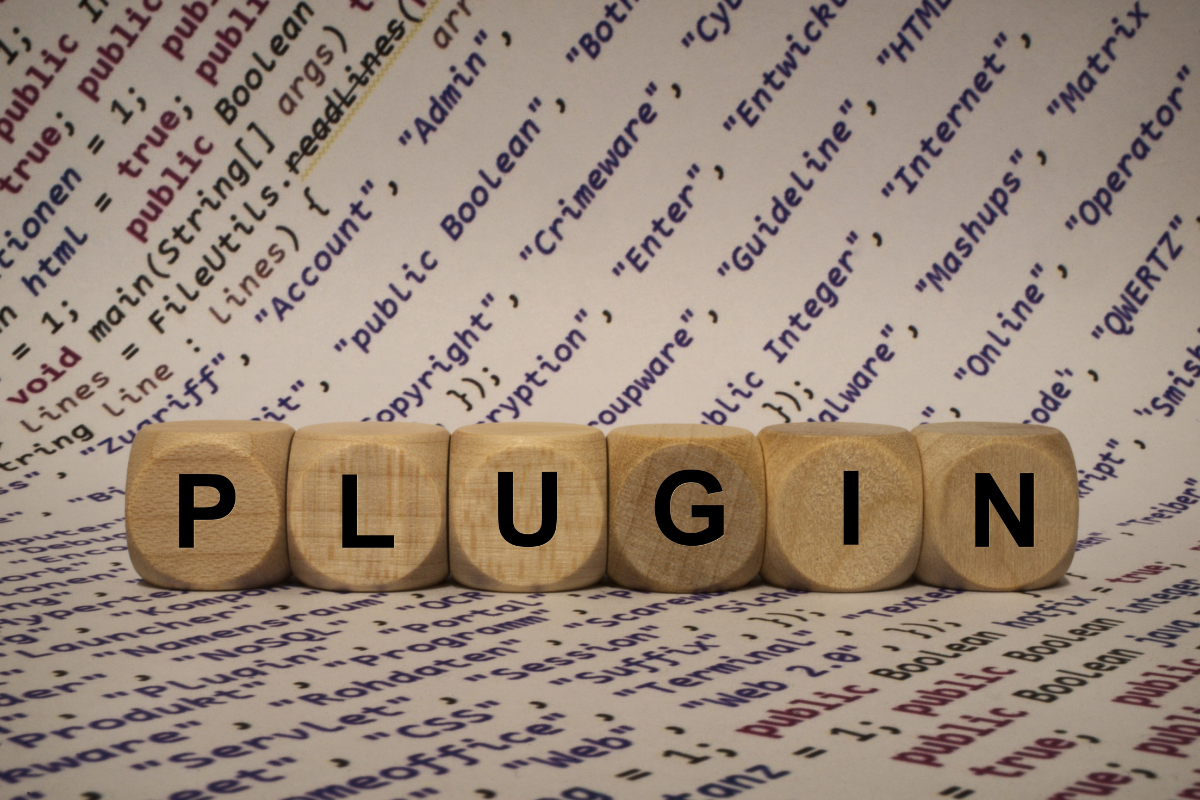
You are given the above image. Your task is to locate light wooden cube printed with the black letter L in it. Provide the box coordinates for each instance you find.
[288,422,450,591]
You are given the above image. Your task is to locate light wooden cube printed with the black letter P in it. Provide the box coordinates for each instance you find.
[125,421,294,589]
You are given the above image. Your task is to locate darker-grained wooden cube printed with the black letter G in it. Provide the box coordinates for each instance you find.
[608,425,767,591]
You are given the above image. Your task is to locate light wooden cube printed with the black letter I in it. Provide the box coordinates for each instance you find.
[758,422,923,591]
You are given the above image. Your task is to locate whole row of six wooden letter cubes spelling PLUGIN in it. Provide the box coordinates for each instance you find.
[126,421,1079,591]
